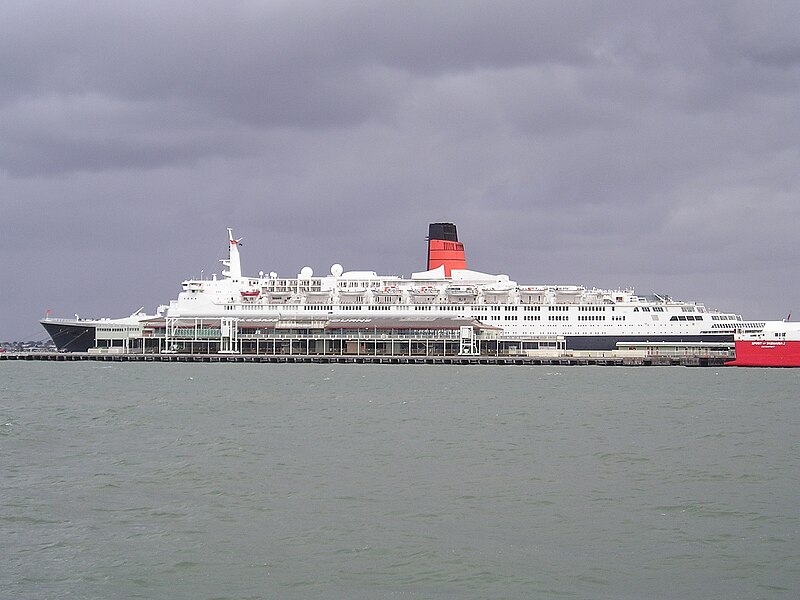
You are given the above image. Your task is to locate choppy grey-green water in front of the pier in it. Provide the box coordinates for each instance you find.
[0,362,800,599]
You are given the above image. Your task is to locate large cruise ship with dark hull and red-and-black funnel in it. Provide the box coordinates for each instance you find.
[41,223,766,352]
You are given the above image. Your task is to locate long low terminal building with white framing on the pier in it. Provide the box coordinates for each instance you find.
[73,317,565,357]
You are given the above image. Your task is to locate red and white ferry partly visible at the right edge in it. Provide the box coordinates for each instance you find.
[726,321,800,367]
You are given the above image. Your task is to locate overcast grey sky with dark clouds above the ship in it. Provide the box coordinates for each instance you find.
[0,0,800,340]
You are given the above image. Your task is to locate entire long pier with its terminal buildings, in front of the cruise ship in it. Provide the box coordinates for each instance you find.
[17,317,733,366]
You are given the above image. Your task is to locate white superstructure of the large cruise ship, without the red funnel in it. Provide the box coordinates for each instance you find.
[165,229,764,350]
